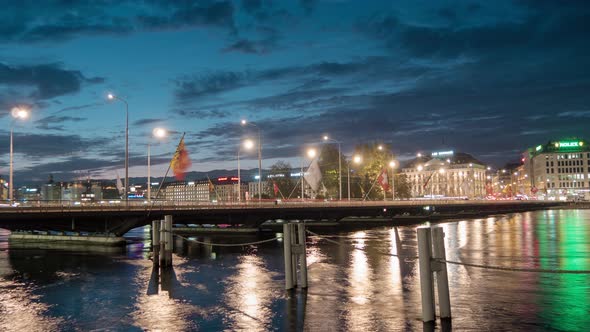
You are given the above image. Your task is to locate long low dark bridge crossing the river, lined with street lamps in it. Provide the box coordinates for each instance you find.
[0,200,567,236]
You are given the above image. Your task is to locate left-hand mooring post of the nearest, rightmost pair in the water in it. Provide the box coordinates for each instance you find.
[417,226,434,322]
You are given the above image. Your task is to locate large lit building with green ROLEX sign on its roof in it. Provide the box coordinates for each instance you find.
[524,138,590,200]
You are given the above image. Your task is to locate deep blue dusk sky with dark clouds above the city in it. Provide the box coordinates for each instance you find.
[0,0,590,182]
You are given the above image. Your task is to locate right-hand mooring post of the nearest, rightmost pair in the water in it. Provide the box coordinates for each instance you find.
[432,226,451,319]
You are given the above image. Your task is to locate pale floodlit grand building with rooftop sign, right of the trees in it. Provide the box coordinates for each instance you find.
[401,151,487,198]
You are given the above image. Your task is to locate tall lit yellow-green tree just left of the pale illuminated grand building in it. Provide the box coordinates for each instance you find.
[351,143,394,200]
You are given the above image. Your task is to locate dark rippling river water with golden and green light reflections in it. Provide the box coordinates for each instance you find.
[0,210,590,331]
